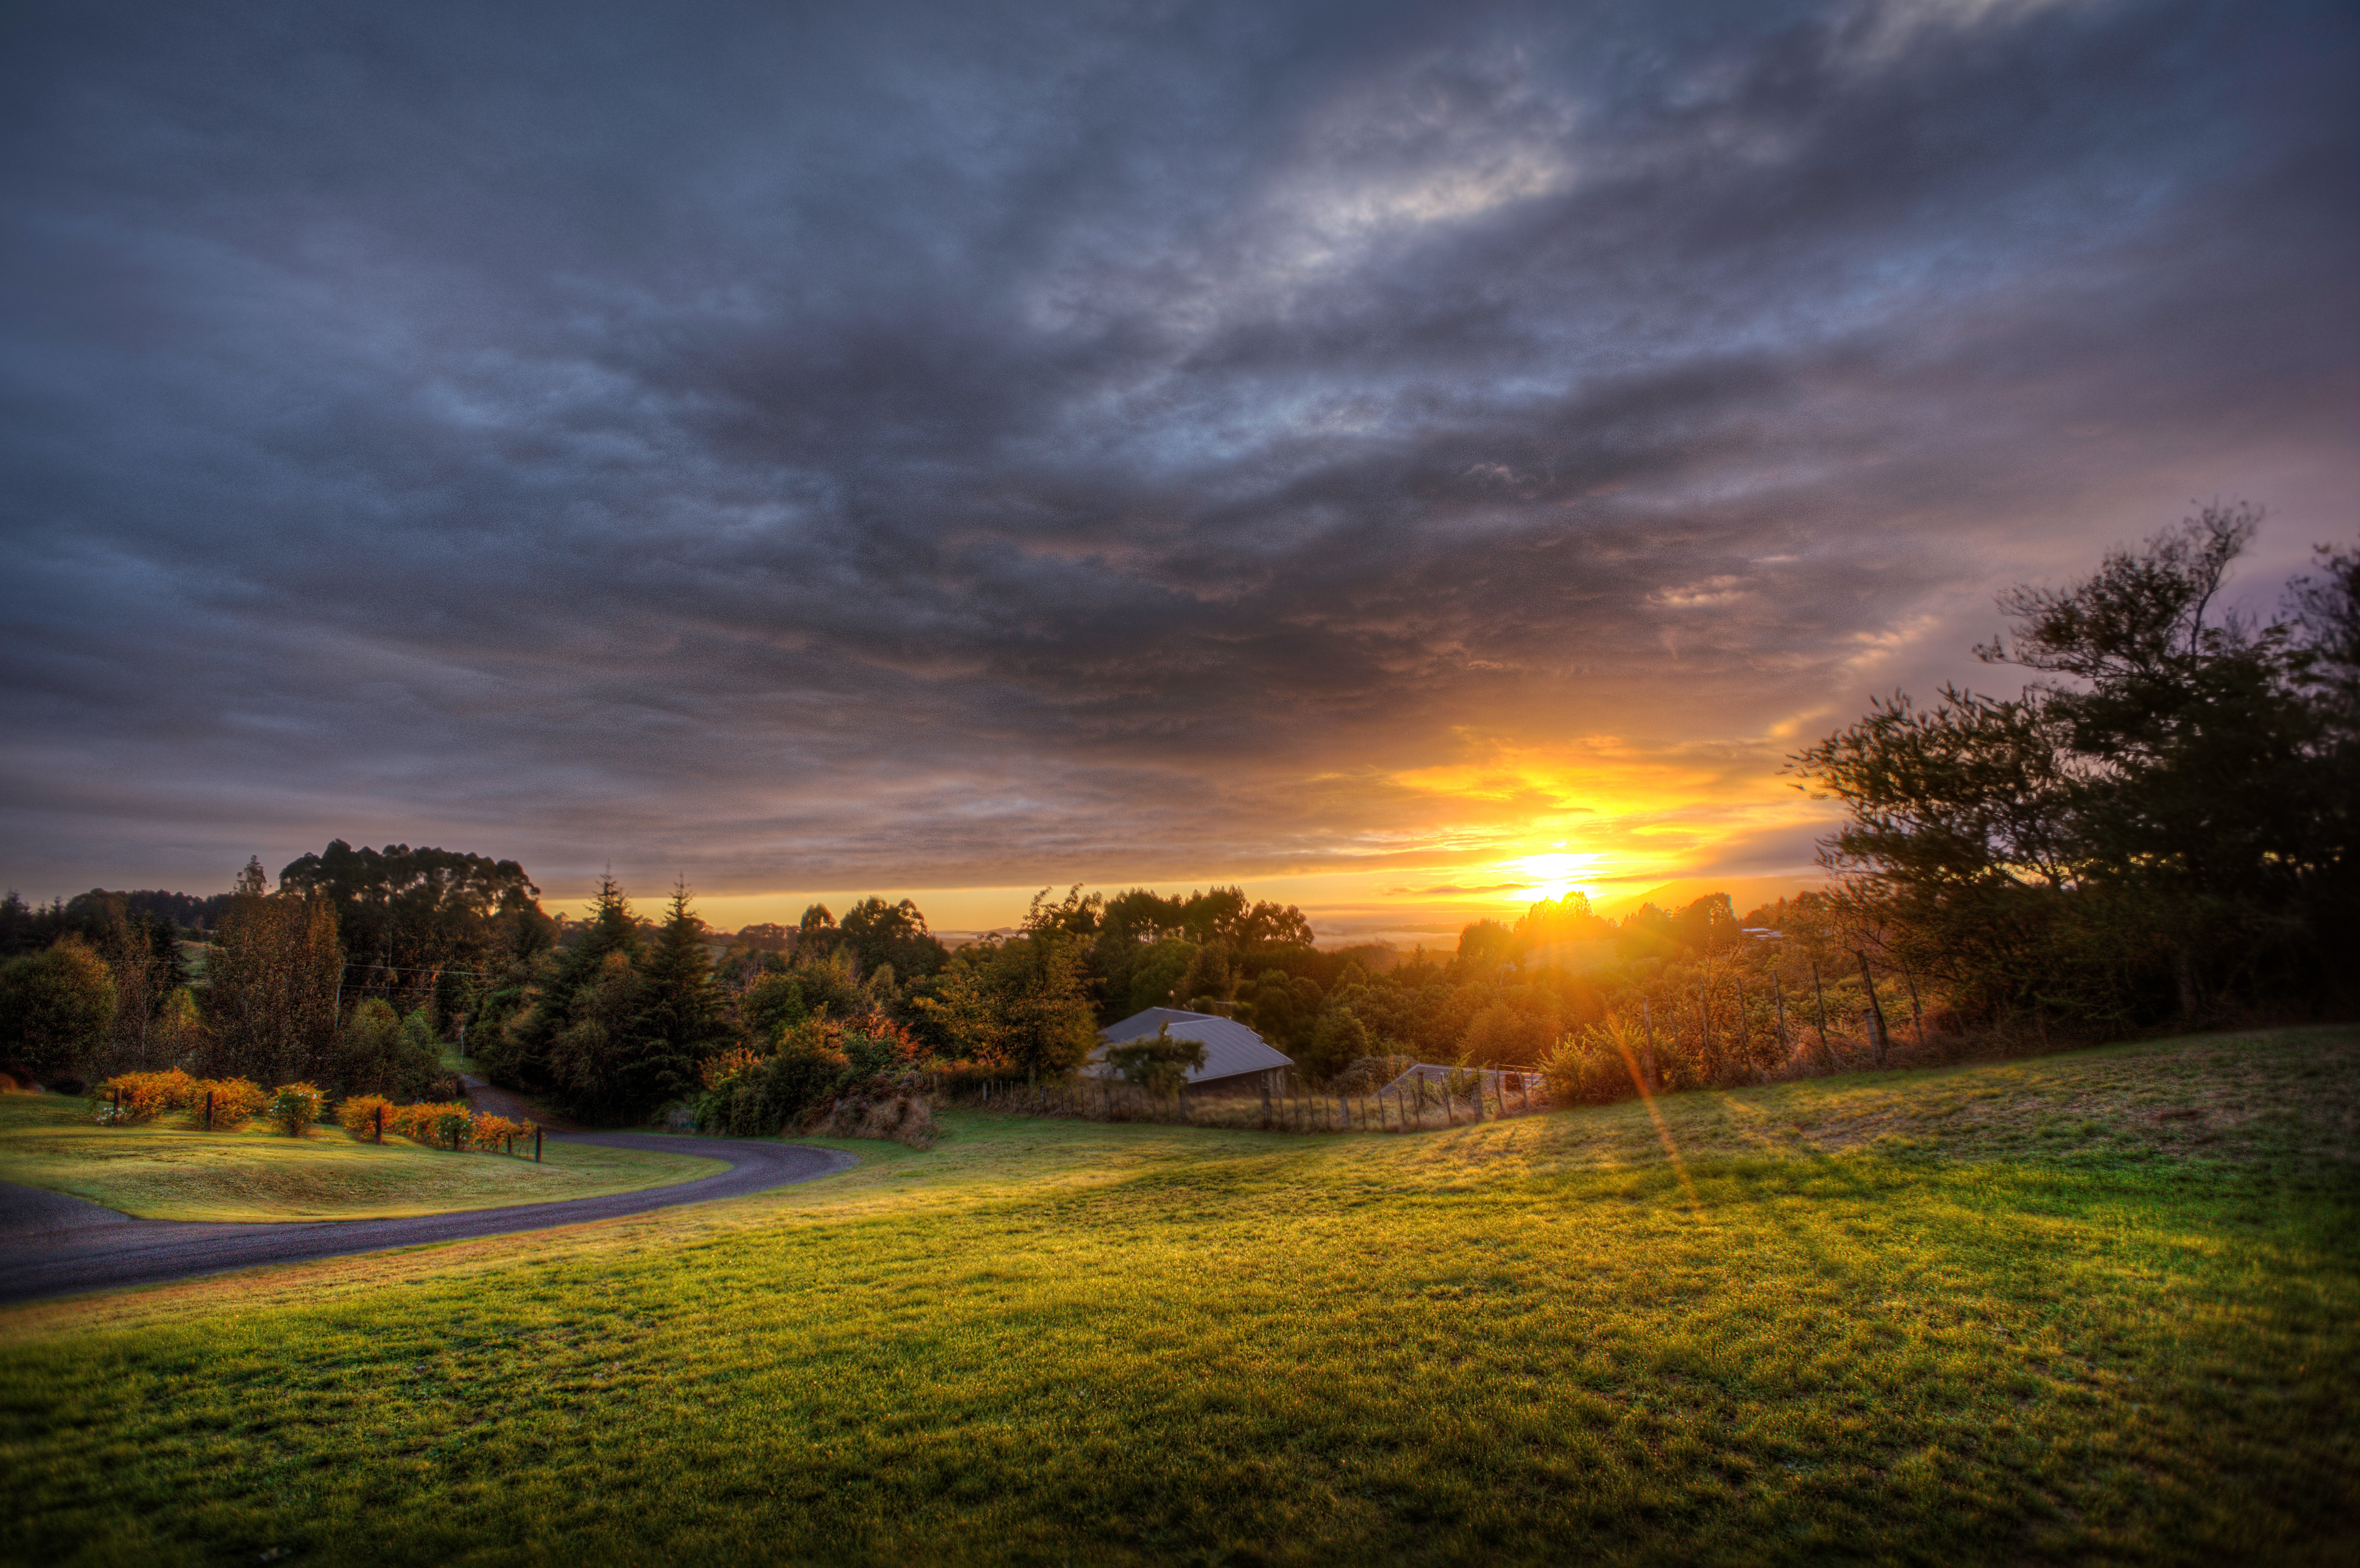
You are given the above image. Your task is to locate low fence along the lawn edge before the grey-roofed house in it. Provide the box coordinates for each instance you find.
[953,1067,1548,1134]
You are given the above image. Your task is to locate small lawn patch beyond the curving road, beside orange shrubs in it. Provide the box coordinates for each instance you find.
[0,1093,722,1221]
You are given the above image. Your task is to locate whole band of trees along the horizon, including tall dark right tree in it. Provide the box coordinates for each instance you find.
[0,508,2360,1131]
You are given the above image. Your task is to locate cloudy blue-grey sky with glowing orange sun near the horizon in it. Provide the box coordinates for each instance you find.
[0,0,2360,942]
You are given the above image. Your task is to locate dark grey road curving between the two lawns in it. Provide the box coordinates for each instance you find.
[0,1134,859,1301]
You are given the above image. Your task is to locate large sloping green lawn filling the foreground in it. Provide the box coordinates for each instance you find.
[0,1029,2360,1563]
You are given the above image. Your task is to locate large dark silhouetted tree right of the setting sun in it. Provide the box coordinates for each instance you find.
[1794,508,2350,1032]
